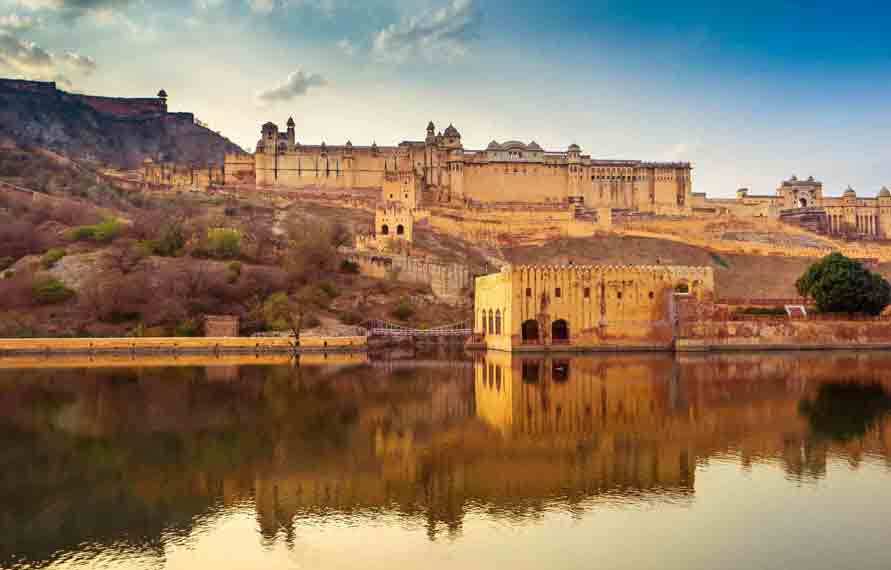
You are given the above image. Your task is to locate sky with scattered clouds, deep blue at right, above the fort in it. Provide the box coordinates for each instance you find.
[0,0,891,197]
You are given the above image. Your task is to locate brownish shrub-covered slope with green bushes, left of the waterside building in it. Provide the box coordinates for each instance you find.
[0,153,470,336]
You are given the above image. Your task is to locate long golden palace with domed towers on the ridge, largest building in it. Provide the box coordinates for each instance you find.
[239,118,692,214]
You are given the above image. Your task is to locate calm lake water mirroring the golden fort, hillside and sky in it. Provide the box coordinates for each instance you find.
[0,346,891,570]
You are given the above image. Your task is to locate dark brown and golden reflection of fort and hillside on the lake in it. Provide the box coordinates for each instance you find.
[0,353,891,567]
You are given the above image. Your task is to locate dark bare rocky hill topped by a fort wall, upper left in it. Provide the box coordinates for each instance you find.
[0,79,243,168]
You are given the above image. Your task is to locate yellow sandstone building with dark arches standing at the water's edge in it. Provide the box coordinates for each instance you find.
[474,265,715,351]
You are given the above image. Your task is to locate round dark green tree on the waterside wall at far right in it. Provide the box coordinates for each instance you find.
[795,253,891,315]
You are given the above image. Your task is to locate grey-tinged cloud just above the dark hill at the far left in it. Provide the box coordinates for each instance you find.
[0,32,97,85]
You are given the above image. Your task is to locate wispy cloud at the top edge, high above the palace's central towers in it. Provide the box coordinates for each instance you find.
[373,0,480,61]
